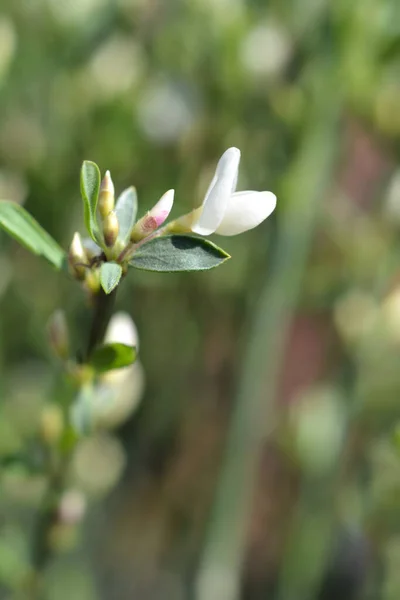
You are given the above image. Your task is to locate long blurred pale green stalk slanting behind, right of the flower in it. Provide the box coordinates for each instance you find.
[195,76,340,600]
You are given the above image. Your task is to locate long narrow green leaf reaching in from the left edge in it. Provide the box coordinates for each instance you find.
[0,200,65,269]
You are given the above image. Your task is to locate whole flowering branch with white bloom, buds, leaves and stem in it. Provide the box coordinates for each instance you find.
[0,148,276,600]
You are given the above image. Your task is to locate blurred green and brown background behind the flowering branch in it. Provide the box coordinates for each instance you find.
[0,0,400,600]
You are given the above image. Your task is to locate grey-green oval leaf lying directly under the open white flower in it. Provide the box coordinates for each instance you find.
[130,235,230,272]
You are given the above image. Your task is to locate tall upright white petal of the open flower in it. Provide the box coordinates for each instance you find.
[192,148,240,235]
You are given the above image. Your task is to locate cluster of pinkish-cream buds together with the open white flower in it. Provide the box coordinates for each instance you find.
[69,148,276,292]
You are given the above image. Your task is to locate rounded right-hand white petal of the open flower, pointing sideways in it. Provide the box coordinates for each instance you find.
[215,192,276,235]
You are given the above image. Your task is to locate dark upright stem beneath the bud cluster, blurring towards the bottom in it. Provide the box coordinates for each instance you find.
[28,289,116,600]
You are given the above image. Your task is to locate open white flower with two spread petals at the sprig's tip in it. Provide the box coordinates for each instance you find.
[190,148,276,235]
